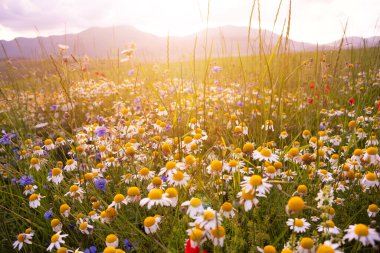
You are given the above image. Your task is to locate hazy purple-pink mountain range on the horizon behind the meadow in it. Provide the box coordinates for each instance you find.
[0,26,380,61]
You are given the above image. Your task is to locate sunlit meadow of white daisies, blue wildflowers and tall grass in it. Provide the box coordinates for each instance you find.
[0,39,380,253]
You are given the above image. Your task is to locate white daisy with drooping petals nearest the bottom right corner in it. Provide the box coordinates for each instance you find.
[343,224,380,246]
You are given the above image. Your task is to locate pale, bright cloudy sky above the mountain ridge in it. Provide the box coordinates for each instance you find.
[0,0,380,44]
